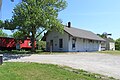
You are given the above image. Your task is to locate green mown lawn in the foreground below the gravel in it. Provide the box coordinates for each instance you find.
[0,62,114,80]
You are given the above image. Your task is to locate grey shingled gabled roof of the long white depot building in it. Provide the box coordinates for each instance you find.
[64,27,105,41]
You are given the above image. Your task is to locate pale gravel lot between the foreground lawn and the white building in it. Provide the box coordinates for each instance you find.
[7,53,120,79]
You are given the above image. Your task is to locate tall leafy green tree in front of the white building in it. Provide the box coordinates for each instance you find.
[5,0,67,51]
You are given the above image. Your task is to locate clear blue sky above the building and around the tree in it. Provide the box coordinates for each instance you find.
[1,0,120,39]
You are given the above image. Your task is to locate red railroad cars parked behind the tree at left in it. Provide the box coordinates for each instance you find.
[0,37,36,50]
